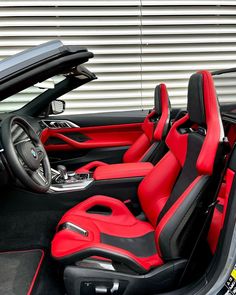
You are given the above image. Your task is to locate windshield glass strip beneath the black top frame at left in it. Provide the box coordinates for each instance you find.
[0,75,65,113]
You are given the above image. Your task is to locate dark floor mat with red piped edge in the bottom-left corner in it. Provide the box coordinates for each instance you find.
[0,250,44,295]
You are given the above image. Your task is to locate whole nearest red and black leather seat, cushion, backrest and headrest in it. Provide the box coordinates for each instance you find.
[51,71,224,274]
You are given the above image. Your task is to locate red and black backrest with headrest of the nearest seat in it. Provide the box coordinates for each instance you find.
[138,71,224,260]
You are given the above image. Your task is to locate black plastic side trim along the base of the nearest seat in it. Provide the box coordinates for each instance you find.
[64,259,186,295]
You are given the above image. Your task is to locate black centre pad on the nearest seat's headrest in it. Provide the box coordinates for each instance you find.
[187,72,206,126]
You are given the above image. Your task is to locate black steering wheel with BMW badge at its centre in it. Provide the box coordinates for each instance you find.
[1,115,51,193]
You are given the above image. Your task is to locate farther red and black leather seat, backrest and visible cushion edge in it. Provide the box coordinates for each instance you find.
[76,84,170,174]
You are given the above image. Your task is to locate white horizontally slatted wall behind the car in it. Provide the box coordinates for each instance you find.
[0,0,236,113]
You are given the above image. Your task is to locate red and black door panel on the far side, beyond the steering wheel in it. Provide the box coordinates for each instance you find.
[41,111,148,170]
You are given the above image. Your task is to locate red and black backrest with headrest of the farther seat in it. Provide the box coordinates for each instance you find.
[123,84,170,163]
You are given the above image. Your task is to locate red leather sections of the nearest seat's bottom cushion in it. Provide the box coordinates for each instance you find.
[52,196,163,270]
